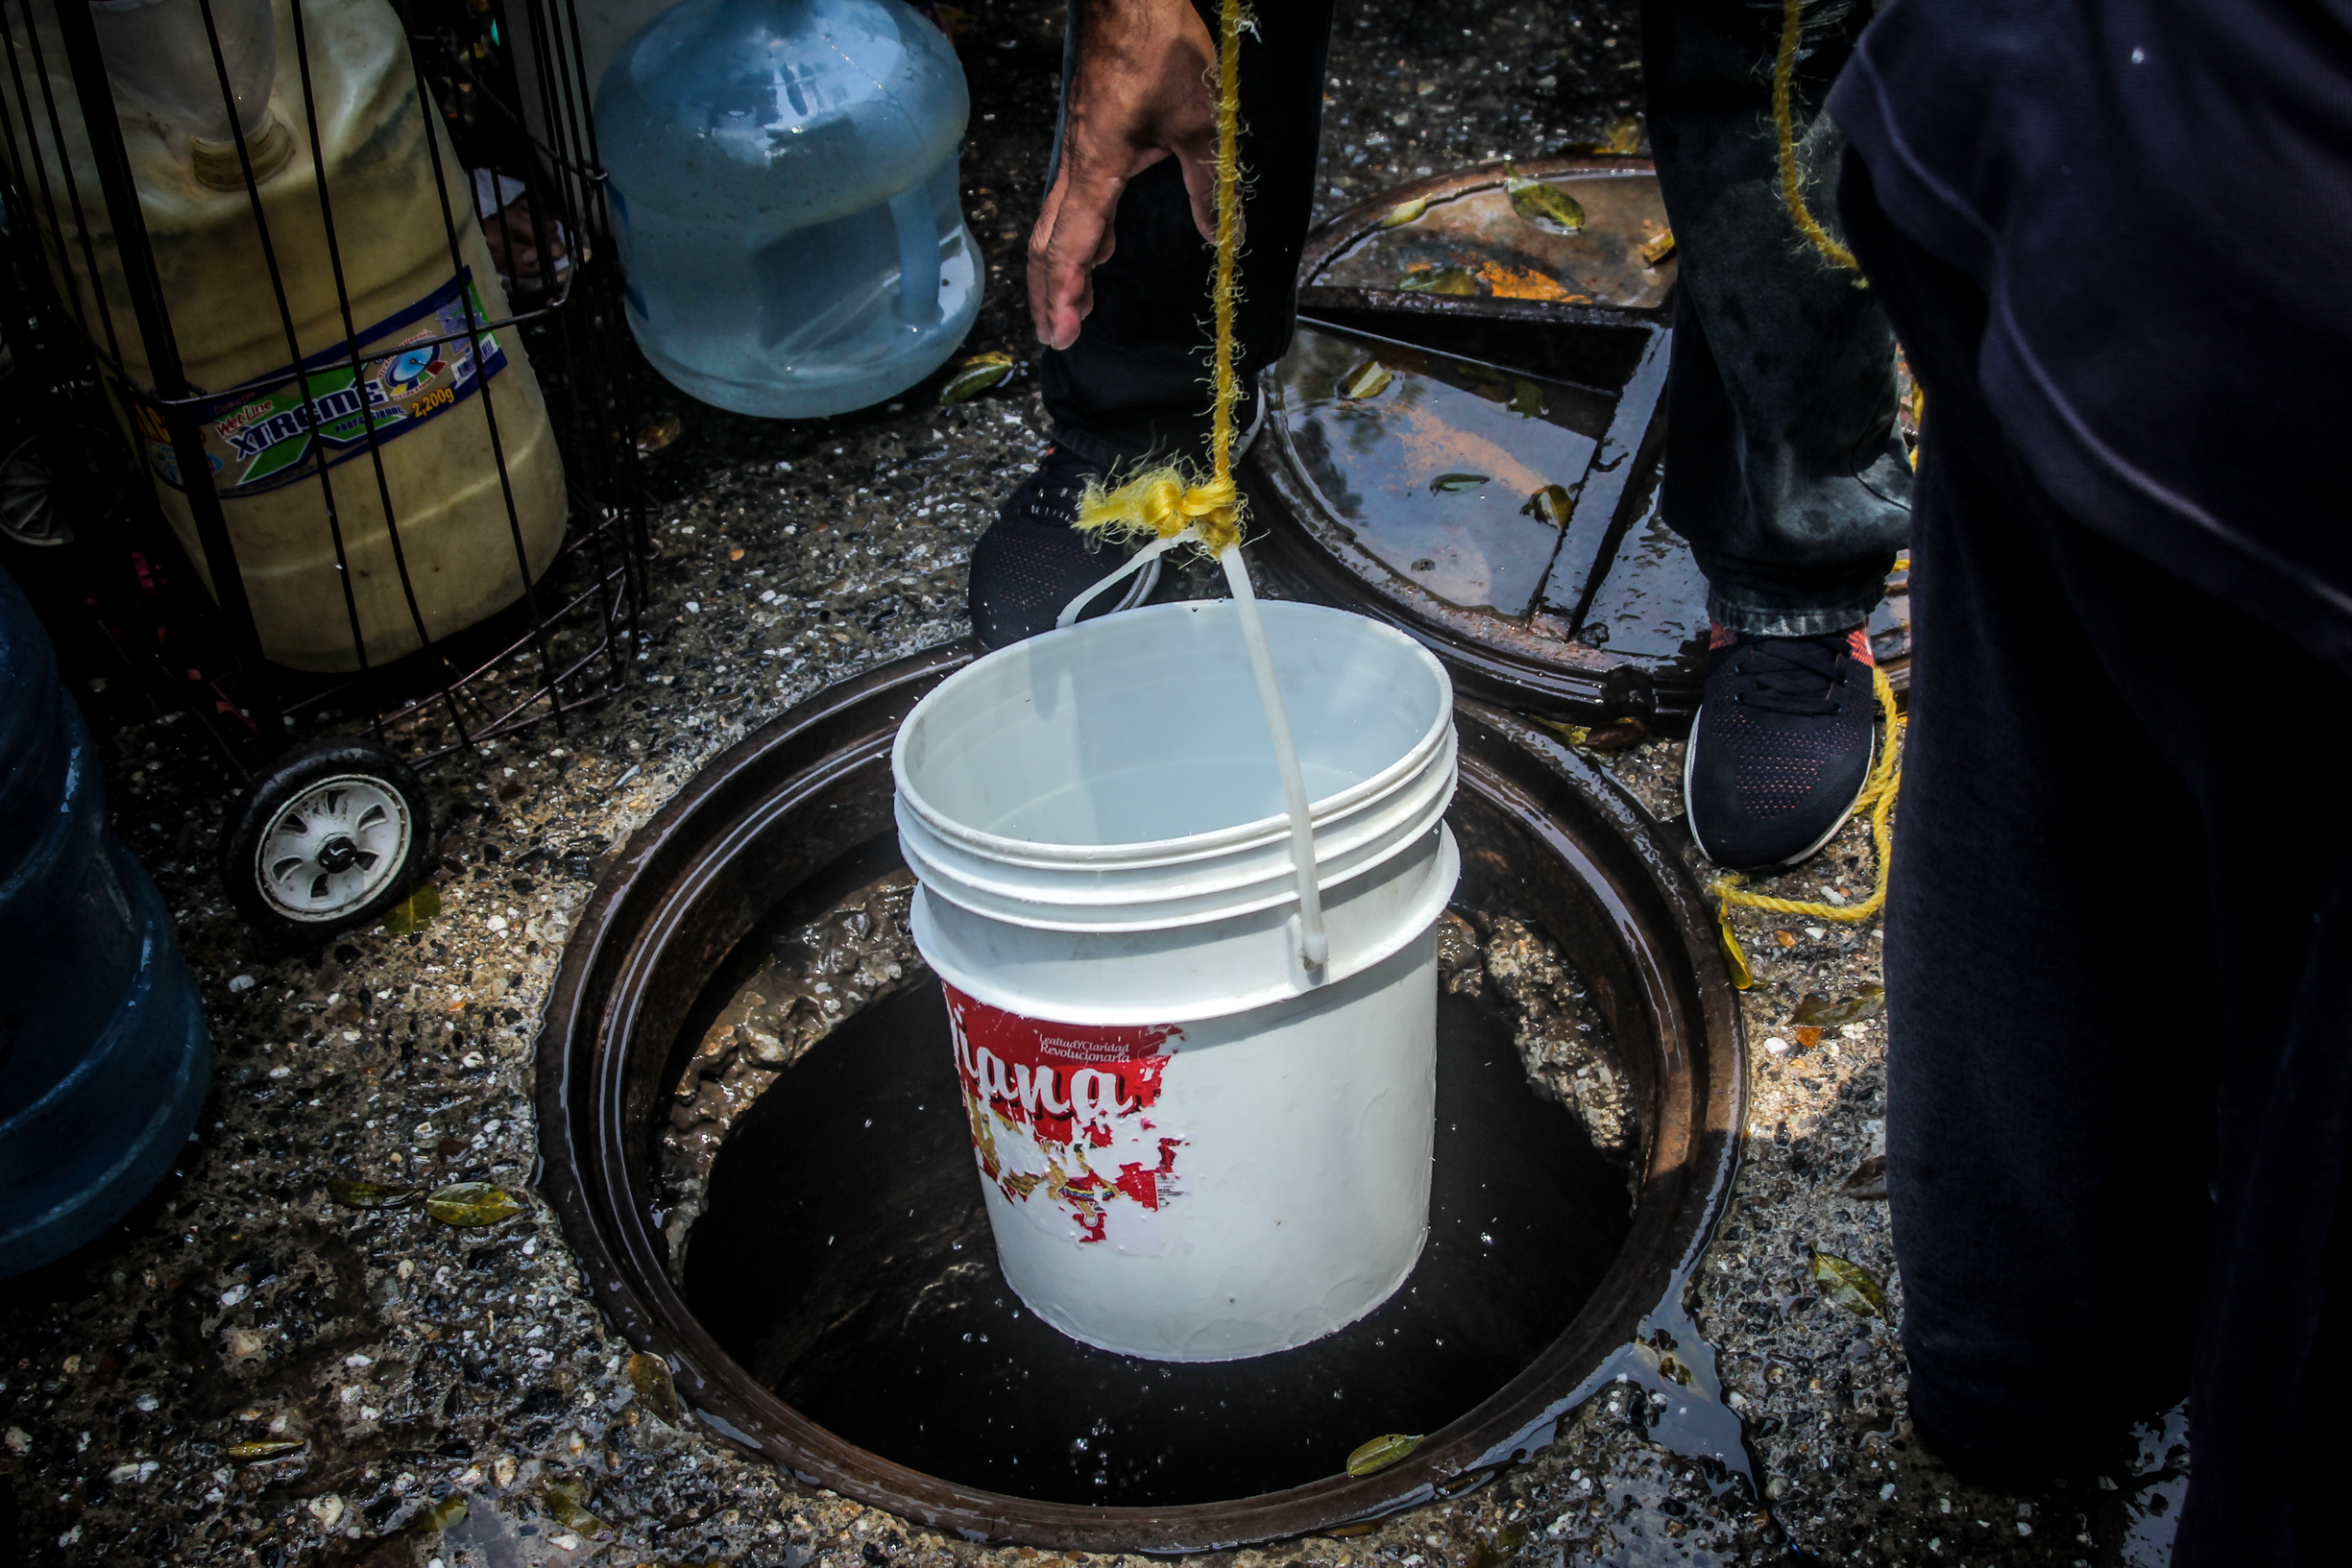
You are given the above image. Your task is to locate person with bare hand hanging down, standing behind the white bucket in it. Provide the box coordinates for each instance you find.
[971,0,1910,870]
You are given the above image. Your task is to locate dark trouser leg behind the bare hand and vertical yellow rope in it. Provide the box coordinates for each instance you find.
[1039,0,1331,466]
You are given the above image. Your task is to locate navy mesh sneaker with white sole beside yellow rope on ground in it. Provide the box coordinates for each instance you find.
[1682,625,1877,872]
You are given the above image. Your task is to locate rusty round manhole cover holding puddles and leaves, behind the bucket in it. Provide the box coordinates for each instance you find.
[1242,157,1910,719]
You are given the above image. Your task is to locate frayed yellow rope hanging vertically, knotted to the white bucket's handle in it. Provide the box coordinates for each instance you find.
[1078,0,1247,555]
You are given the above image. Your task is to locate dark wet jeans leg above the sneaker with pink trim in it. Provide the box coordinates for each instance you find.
[1641,0,1910,635]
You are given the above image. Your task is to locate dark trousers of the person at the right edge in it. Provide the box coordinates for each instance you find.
[1842,159,2352,1568]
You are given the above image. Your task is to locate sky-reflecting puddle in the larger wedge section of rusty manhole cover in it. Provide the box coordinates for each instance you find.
[1282,326,1613,615]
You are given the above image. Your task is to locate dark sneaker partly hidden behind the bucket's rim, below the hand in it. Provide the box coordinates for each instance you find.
[971,446,1159,651]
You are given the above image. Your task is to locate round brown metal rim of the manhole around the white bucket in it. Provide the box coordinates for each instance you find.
[536,639,1748,1554]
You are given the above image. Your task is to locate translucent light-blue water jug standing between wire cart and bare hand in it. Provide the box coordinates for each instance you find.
[595,0,981,419]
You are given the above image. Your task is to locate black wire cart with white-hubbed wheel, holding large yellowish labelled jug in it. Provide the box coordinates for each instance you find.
[0,0,646,943]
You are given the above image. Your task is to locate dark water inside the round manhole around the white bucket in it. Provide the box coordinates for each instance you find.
[685,977,1637,1505]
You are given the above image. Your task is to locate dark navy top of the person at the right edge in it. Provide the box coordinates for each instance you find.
[1830,0,2352,672]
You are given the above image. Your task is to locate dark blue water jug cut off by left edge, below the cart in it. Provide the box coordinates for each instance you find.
[0,571,211,1276]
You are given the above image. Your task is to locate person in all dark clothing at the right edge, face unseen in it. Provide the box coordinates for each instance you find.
[1830,0,2352,1568]
